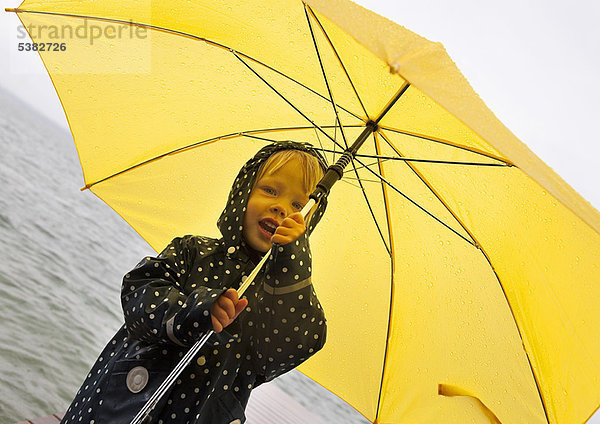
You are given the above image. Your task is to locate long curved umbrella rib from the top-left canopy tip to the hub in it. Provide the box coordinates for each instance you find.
[10,9,364,126]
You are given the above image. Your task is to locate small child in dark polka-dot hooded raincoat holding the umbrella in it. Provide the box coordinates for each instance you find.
[62,142,326,424]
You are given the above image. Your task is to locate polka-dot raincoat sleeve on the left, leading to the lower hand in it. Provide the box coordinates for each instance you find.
[121,236,226,346]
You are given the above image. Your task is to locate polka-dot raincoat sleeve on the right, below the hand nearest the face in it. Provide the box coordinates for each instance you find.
[247,235,327,381]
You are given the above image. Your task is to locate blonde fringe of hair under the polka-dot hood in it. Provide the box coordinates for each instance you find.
[254,149,323,194]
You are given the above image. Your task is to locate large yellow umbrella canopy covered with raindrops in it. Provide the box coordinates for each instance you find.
[10,0,600,423]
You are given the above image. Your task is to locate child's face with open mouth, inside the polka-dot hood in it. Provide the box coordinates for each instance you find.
[242,159,310,253]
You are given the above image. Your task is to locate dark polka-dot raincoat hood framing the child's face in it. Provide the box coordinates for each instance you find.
[217,141,327,255]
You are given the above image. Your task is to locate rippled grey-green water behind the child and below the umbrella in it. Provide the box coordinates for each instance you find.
[0,90,367,424]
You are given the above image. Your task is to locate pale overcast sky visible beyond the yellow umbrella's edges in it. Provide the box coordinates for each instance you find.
[0,0,600,424]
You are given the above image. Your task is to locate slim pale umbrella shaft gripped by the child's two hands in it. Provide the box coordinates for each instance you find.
[130,199,317,424]
